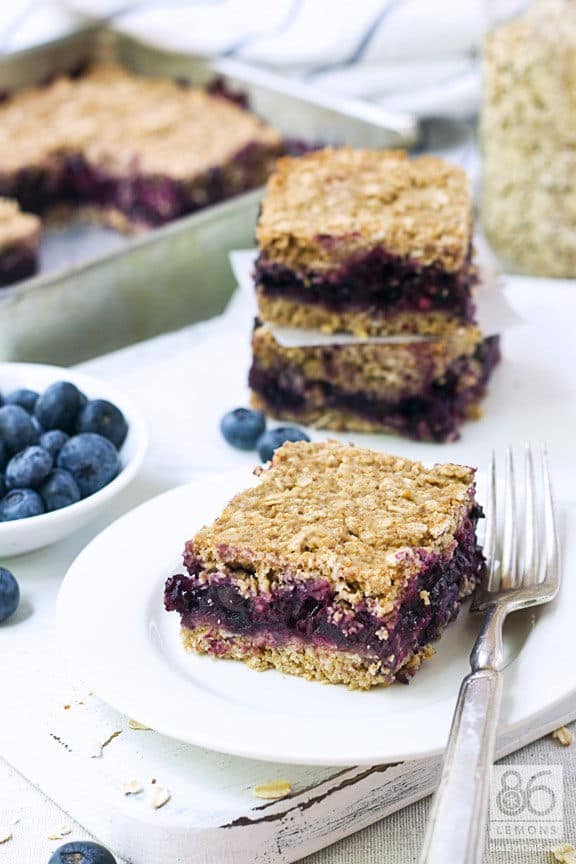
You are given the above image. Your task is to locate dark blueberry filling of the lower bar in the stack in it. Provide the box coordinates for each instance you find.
[248,336,500,441]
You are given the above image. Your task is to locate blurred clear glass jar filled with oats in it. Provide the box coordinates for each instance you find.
[480,0,576,277]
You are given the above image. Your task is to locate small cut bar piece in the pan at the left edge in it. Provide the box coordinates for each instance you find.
[0,198,40,287]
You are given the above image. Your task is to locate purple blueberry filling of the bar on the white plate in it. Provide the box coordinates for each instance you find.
[164,505,484,671]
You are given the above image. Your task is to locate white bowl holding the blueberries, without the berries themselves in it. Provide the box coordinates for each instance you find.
[0,363,148,557]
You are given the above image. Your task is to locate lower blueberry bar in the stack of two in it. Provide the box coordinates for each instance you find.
[249,324,500,442]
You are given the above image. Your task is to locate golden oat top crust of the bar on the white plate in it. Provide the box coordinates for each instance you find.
[191,441,474,603]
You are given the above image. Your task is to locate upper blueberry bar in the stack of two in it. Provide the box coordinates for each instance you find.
[255,147,477,337]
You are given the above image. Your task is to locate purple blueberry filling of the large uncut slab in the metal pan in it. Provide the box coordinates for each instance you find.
[0,142,272,225]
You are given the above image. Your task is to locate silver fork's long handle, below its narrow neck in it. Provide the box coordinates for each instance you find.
[420,668,502,864]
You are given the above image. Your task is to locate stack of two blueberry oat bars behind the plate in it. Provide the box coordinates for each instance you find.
[249,148,499,441]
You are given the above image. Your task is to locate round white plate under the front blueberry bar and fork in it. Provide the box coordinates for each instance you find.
[58,469,576,765]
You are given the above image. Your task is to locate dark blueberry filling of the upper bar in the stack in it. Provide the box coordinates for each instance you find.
[255,248,477,322]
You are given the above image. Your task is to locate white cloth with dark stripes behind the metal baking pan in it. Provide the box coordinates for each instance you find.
[0,0,500,116]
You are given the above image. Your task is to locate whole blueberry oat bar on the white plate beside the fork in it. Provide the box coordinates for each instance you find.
[164,441,484,689]
